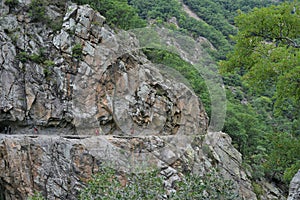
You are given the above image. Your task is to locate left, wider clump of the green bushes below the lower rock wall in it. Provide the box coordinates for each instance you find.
[79,167,164,200]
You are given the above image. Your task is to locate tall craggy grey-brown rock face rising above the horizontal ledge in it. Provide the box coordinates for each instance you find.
[0,1,207,135]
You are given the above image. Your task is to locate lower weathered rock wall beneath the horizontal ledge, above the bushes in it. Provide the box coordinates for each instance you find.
[0,133,256,200]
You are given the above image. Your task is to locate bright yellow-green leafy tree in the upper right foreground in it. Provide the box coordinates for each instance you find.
[220,3,300,112]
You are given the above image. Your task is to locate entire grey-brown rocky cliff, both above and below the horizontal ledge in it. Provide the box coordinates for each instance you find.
[0,1,286,199]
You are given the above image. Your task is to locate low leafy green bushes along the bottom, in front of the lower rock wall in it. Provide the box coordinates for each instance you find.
[80,167,239,200]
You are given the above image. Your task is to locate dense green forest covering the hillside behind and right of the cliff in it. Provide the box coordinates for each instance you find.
[19,0,300,198]
